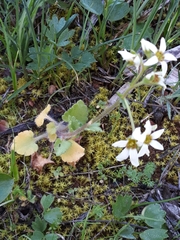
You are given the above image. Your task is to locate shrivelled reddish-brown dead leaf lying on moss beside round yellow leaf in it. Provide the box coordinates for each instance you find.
[31,152,54,173]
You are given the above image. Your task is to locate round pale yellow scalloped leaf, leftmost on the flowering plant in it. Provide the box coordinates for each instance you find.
[11,130,38,156]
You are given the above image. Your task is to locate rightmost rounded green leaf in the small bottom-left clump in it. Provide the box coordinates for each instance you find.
[43,207,62,224]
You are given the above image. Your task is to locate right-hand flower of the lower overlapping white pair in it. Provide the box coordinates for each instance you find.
[138,120,164,157]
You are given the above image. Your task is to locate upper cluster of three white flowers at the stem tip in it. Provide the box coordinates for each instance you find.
[118,37,177,89]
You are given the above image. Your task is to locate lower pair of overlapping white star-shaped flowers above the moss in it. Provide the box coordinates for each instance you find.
[112,120,164,167]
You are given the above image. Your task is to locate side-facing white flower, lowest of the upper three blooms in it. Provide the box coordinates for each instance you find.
[144,72,166,89]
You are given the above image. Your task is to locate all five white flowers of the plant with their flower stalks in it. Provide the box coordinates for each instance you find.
[112,37,177,167]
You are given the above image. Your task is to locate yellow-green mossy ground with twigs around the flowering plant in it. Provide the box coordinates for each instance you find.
[0,1,180,240]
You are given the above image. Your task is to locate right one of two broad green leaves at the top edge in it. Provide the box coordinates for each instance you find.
[107,1,130,22]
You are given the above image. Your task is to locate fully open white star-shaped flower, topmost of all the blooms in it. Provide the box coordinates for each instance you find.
[141,37,177,76]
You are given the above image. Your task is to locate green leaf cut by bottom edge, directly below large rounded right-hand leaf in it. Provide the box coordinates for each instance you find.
[139,228,168,240]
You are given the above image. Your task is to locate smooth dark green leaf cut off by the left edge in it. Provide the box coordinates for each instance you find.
[0,173,14,203]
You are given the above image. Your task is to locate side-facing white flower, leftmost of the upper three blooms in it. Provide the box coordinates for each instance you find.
[118,49,141,71]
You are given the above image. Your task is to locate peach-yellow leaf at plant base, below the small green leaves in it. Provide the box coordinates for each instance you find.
[60,140,85,167]
